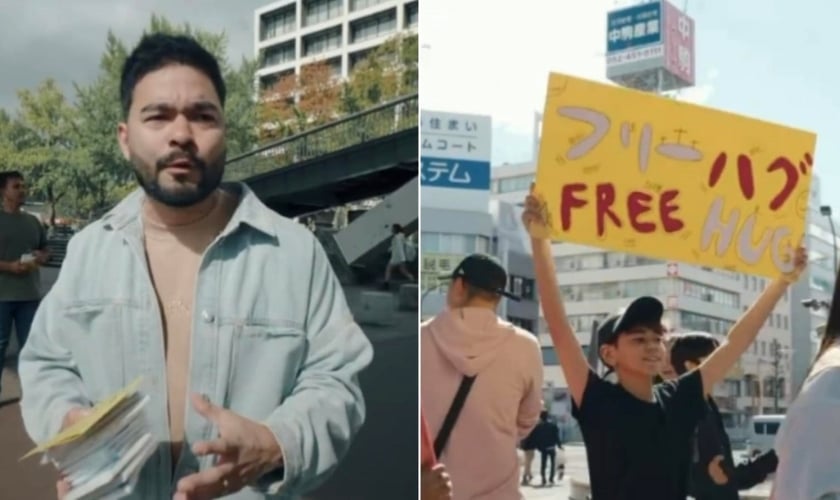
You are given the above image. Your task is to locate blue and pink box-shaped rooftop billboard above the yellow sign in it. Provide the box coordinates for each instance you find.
[606,0,695,91]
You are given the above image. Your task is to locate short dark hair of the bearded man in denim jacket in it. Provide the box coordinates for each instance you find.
[120,33,227,116]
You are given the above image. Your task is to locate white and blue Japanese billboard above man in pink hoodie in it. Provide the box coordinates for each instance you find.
[420,110,492,212]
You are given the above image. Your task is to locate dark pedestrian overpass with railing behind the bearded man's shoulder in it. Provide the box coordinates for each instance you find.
[225,94,418,217]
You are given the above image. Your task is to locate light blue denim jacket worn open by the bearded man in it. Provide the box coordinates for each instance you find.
[19,184,373,500]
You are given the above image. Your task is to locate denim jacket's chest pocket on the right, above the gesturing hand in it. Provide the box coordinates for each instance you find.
[226,323,307,412]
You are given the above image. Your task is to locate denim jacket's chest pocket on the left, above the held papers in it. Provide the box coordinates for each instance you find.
[60,300,128,402]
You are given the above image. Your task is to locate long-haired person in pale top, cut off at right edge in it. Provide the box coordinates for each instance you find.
[771,264,840,500]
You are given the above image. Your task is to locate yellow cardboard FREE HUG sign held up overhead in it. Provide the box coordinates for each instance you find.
[536,74,816,277]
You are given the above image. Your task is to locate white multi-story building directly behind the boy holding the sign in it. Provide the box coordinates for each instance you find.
[491,162,808,437]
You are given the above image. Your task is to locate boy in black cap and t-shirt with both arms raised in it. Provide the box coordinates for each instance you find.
[522,191,807,500]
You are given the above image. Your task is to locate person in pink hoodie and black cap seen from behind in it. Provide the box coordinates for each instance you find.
[420,254,543,500]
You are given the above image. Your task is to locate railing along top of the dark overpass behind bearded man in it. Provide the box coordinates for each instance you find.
[225,94,419,181]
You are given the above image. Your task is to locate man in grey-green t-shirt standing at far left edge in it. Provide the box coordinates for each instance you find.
[0,171,48,398]
